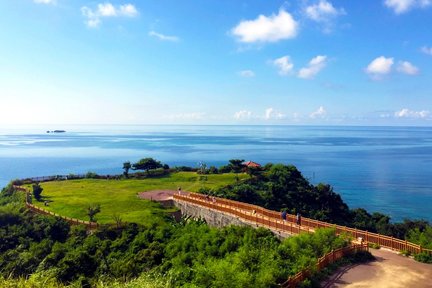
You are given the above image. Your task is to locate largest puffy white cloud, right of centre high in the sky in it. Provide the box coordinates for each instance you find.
[231,9,298,43]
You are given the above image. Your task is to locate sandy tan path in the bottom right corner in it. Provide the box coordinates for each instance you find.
[322,249,432,288]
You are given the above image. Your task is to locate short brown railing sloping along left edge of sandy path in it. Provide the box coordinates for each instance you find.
[280,243,368,288]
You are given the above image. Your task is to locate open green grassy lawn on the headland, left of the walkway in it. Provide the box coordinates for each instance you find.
[34,172,248,224]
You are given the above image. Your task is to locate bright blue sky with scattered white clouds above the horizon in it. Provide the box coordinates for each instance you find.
[0,0,432,125]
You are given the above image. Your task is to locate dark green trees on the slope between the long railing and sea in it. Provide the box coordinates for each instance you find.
[201,164,432,254]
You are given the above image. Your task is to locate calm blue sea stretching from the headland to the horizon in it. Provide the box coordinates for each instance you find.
[0,126,432,221]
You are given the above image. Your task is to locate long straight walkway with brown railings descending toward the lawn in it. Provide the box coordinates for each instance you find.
[174,193,432,254]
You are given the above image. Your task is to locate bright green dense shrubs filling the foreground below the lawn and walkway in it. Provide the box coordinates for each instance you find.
[0,187,347,287]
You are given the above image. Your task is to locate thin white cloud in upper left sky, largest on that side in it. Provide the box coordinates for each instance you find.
[82,0,138,28]
